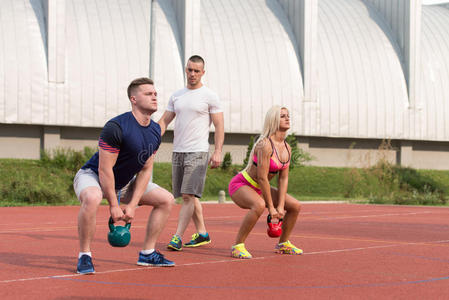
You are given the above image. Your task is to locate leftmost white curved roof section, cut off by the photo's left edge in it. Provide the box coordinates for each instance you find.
[0,0,48,123]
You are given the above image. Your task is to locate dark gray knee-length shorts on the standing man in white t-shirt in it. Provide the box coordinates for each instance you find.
[172,152,209,198]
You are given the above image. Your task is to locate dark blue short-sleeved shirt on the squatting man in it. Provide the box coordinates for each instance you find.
[82,112,161,190]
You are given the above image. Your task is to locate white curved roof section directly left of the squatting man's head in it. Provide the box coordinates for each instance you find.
[64,0,150,126]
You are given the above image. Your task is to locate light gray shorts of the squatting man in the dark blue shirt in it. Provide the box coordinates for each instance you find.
[73,169,159,203]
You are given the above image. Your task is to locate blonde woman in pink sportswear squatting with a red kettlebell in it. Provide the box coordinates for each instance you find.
[229,106,303,259]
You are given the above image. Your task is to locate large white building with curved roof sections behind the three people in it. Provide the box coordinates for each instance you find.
[0,0,449,169]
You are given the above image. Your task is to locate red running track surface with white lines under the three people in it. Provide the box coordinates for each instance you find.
[0,203,449,299]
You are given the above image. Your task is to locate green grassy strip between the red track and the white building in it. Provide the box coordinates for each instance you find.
[0,156,449,206]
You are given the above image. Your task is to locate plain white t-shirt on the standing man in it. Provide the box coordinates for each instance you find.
[167,85,223,152]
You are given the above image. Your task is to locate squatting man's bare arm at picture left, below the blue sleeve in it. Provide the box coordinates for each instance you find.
[98,148,123,222]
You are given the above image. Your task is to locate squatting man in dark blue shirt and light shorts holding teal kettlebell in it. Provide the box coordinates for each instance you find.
[73,78,175,274]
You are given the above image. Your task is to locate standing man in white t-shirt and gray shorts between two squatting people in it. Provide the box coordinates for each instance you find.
[159,55,224,251]
